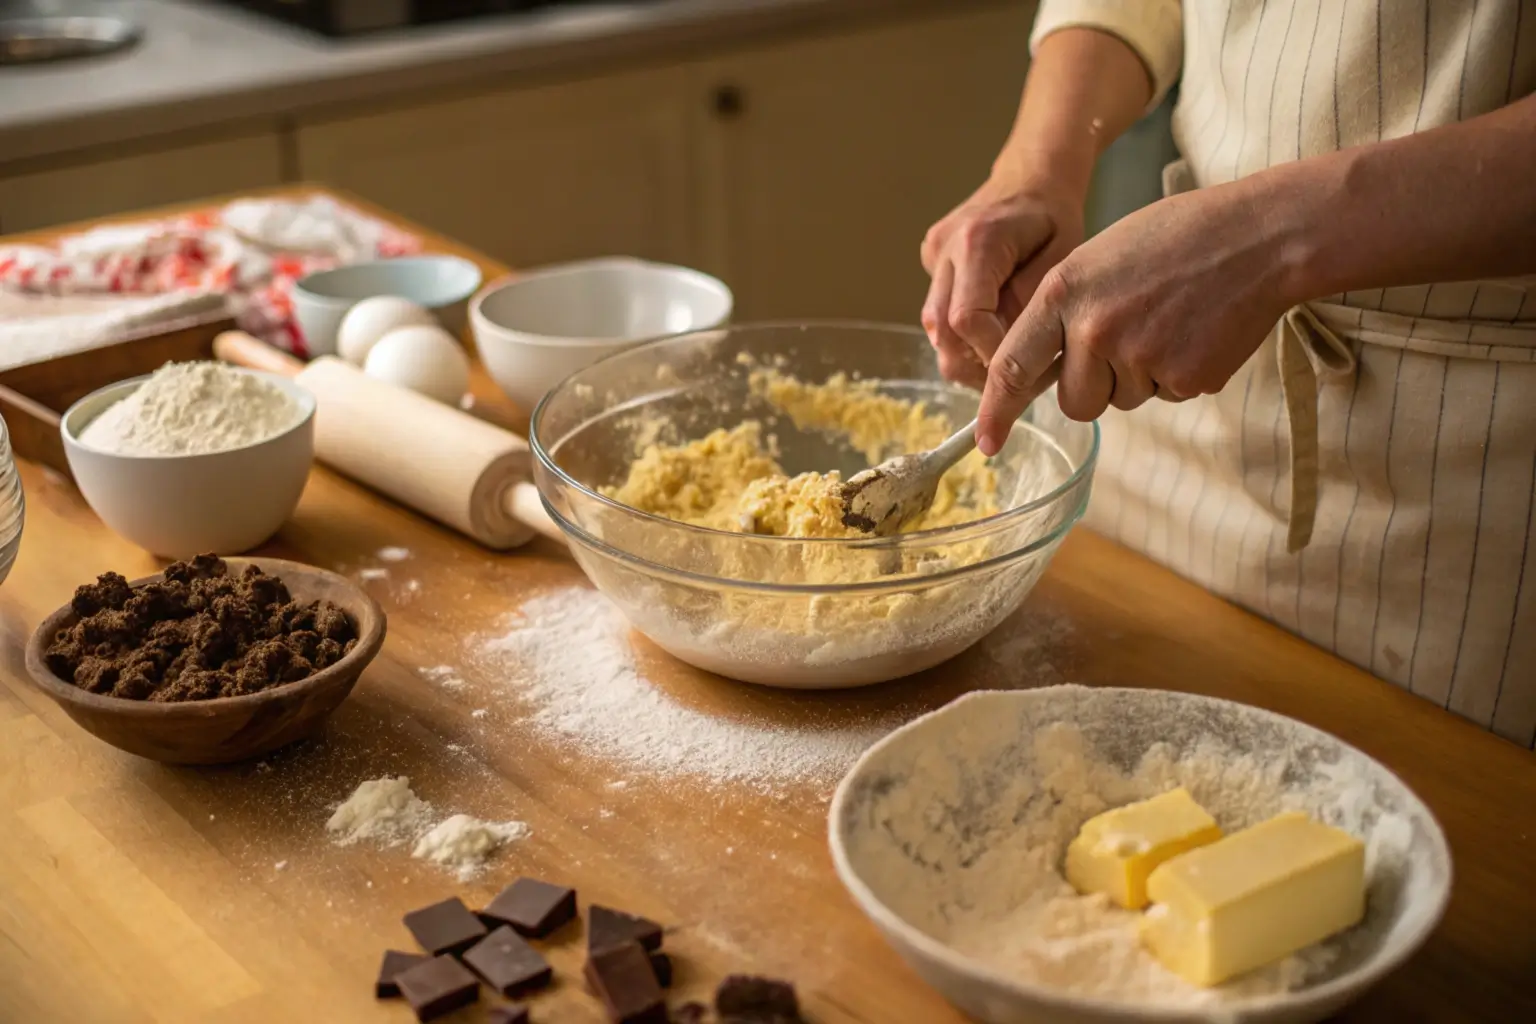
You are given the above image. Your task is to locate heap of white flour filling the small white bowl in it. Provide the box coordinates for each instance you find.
[80,362,303,456]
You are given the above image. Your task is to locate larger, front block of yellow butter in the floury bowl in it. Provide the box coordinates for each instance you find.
[1141,814,1366,986]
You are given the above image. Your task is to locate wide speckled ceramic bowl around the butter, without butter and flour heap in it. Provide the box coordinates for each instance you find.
[829,686,1452,1024]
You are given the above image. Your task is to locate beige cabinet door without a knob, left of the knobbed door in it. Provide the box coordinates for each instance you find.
[298,69,693,267]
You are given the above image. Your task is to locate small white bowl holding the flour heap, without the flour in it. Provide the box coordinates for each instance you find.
[60,370,315,559]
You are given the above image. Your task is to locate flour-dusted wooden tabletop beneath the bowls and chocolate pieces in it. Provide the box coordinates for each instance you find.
[0,190,1536,1024]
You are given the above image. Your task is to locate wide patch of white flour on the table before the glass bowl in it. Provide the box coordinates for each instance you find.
[475,588,899,788]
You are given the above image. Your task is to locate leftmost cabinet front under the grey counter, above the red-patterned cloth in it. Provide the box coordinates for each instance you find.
[0,130,283,233]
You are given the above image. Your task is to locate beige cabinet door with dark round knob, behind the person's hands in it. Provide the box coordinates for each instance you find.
[696,2,1034,322]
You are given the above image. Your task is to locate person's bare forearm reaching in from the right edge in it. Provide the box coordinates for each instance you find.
[1253,97,1536,302]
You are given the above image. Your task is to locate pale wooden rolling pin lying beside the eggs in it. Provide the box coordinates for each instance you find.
[214,330,565,551]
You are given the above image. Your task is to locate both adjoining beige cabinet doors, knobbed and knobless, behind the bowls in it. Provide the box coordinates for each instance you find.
[296,2,1034,322]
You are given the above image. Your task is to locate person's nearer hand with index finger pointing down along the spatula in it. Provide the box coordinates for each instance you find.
[977,186,1296,456]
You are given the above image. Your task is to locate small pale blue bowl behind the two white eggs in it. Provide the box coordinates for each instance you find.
[293,255,481,356]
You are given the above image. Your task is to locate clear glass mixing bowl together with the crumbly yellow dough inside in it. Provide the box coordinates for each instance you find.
[530,322,1098,688]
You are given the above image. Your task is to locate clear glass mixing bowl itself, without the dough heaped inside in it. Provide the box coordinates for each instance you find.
[530,322,1098,688]
